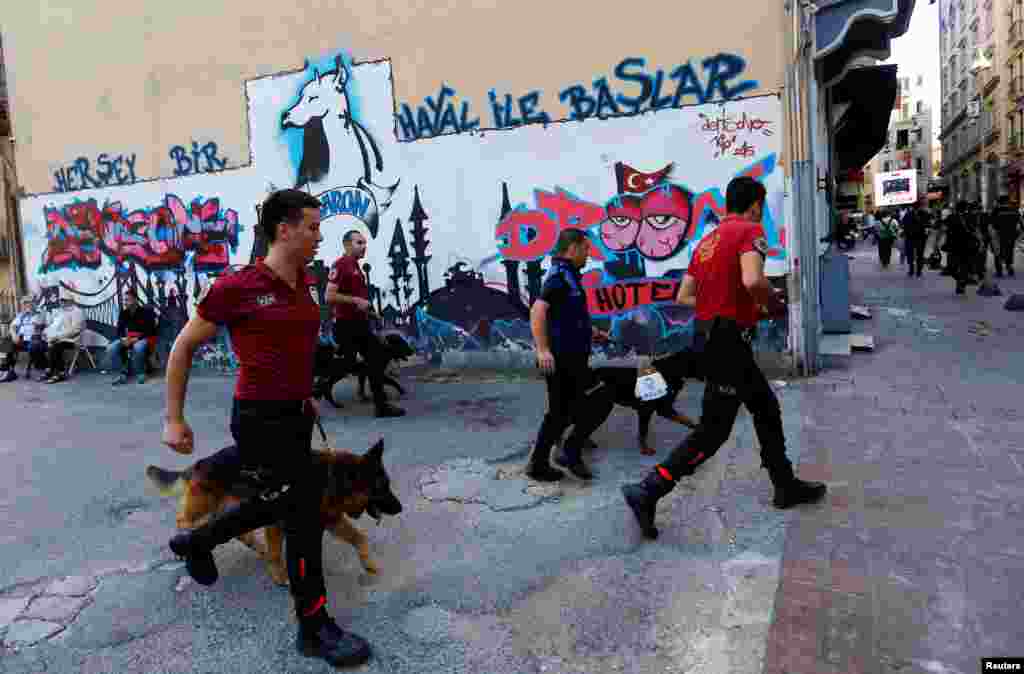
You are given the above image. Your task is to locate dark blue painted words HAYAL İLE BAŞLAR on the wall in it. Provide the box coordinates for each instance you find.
[396,53,758,141]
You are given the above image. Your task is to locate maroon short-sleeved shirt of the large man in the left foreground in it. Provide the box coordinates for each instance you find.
[196,262,321,401]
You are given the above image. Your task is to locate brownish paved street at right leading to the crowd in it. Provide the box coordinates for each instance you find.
[764,249,1024,674]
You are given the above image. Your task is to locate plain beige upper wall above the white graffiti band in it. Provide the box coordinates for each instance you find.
[2,0,787,194]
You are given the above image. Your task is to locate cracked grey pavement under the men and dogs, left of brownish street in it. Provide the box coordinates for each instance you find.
[0,354,799,674]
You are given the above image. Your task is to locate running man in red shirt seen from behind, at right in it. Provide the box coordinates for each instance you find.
[623,177,825,539]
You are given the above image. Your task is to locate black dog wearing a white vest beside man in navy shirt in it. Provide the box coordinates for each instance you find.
[594,349,702,456]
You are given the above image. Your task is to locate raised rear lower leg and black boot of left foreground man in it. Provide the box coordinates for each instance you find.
[168,499,279,585]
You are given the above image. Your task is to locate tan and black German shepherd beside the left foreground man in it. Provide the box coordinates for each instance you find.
[145,440,401,585]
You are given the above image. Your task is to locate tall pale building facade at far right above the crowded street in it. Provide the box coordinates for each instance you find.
[939,0,1007,208]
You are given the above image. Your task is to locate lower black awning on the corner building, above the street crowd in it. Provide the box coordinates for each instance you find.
[833,65,897,171]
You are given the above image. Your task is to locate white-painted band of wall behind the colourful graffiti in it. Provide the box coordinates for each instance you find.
[20,51,788,354]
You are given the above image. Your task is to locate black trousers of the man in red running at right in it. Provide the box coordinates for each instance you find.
[660,319,794,486]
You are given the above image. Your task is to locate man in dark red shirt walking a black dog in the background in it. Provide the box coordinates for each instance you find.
[325,229,406,417]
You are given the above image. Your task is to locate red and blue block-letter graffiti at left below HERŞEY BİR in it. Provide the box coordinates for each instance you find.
[38,195,239,273]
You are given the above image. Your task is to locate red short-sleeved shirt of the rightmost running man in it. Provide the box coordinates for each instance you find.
[686,215,768,328]
